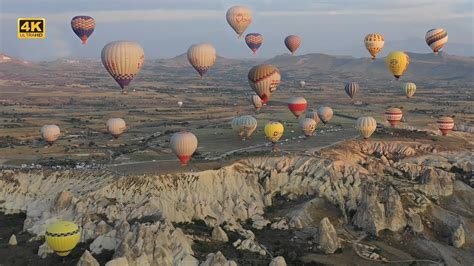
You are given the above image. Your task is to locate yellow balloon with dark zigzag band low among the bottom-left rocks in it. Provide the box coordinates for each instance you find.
[45,221,81,257]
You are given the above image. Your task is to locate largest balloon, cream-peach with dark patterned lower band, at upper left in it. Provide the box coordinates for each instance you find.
[101,41,145,94]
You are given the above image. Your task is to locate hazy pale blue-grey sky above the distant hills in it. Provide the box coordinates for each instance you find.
[0,0,474,61]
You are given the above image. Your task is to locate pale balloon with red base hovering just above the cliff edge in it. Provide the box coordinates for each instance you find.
[170,131,198,166]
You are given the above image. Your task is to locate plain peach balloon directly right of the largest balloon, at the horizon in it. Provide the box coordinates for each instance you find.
[188,43,217,77]
